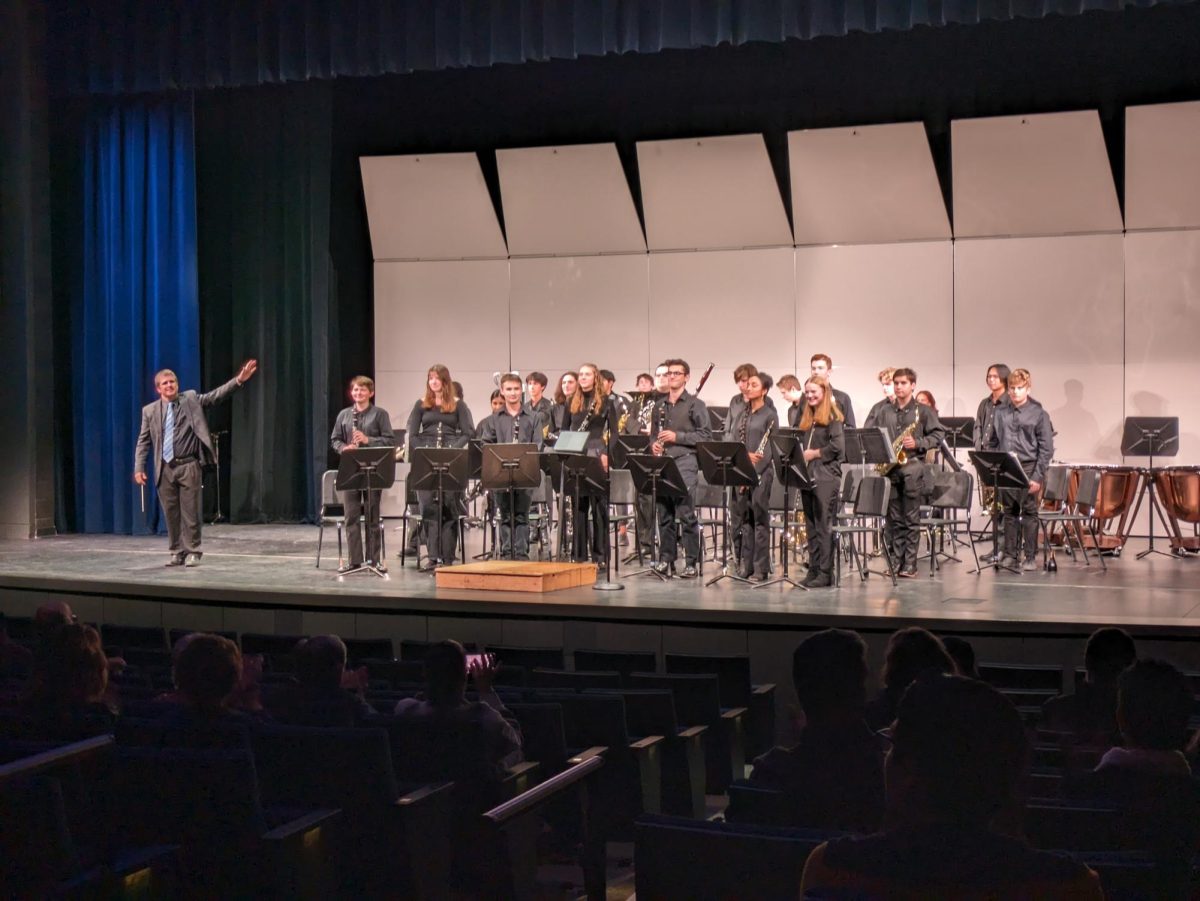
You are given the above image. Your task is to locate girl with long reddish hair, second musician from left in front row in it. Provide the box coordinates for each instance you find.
[407,364,475,572]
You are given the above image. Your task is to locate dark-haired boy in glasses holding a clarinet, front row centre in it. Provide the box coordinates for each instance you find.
[650,359,715,578]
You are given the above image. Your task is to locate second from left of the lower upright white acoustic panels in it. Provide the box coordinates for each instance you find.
[511,253,649,376]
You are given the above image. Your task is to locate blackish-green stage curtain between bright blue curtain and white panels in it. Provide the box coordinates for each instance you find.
[196,82,337,522]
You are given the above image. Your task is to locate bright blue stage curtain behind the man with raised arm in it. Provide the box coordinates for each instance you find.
[71,95,200,534]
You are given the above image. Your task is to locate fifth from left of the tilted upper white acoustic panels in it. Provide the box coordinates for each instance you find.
[950,109,1122,238]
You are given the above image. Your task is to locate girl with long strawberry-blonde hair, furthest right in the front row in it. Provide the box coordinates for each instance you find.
[798,376,846,588]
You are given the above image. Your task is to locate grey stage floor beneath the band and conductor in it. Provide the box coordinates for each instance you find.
[0,524,1200,632]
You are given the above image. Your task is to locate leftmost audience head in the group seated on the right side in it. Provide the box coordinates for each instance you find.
[792,629,868,723]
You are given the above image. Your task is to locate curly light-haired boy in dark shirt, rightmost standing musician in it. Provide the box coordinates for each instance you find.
[995,370,1054,572]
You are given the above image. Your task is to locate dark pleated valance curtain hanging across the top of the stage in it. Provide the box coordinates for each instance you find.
[48,0,1189,94]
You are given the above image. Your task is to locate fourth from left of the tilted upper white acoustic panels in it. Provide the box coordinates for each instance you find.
[787,122,950,245]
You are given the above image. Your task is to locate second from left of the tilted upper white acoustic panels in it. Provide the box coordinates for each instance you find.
[496,144,646,257]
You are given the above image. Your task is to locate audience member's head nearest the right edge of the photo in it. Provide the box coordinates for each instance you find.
[1117,660,1194,751]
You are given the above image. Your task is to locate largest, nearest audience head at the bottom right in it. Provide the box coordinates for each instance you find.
[884,672,1028,829]
